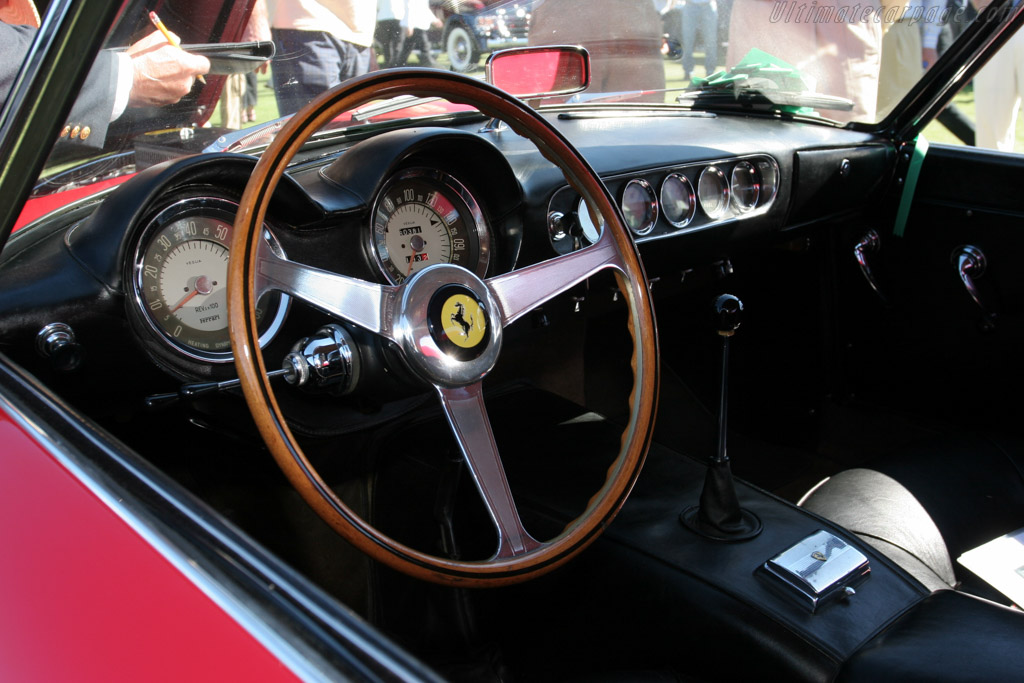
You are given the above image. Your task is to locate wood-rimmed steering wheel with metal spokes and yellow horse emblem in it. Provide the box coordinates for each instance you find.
[228,70,658,586]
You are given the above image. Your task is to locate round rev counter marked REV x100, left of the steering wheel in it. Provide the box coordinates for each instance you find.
[132,198,288,362]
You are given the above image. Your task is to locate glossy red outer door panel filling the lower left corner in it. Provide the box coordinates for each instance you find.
[0,403,296,682]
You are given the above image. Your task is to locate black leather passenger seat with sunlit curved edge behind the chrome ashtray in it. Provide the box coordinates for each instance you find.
[801,434,1024,601]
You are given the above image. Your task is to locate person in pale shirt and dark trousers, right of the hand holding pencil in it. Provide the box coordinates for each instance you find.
[267,0,377,116]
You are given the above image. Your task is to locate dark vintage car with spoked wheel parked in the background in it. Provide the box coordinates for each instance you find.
[431,0,532,73]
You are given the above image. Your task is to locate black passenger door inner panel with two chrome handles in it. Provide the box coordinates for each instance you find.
[836,146,1024,430]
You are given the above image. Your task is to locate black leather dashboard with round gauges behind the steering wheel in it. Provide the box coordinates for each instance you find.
[0,110,893,423]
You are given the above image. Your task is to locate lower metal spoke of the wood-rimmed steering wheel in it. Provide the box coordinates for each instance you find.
[436,382,544,559]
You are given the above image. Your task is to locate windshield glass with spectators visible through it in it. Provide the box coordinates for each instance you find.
[9,0,1007,197]
